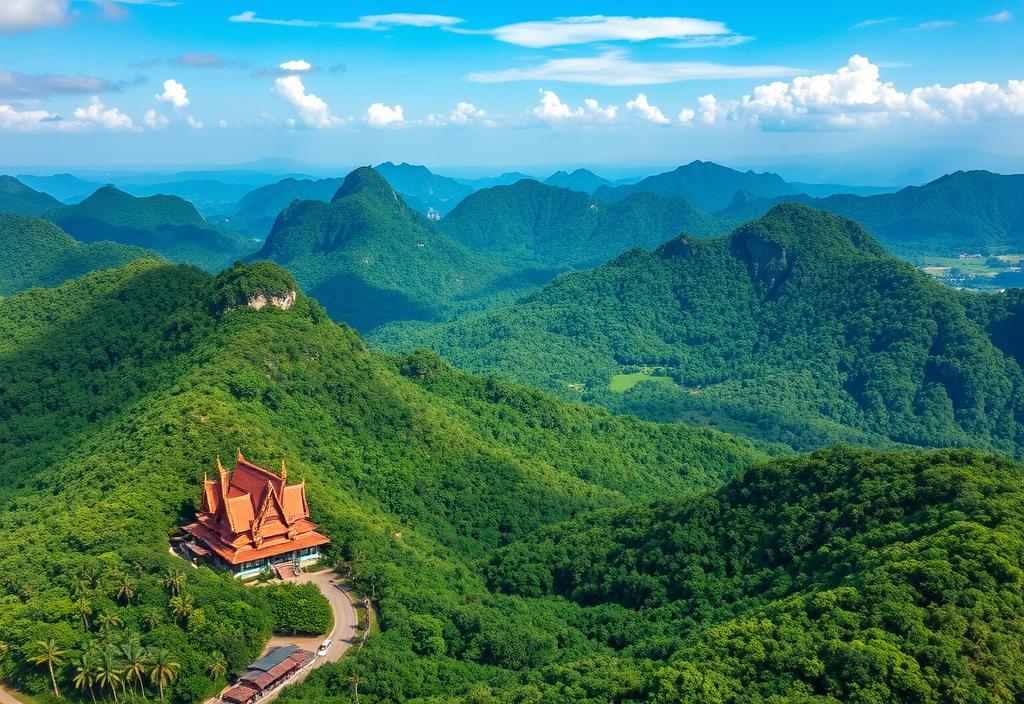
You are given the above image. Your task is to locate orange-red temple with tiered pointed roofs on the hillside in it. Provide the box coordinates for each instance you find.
[184,449,330,577]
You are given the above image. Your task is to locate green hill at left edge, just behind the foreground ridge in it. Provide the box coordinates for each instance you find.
[0,214,154,296]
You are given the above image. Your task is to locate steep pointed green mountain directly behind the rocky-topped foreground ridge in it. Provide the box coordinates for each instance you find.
[253,167,506,331]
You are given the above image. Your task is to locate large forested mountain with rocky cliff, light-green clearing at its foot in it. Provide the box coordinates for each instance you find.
[377,204,1024,454]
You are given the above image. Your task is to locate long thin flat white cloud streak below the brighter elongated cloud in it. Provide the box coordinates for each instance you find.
[469,49,799,86]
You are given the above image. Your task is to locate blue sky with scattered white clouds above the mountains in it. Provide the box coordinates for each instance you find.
[0,0,1024,182]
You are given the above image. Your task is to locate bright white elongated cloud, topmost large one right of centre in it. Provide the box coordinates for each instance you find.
[469,14,733,49]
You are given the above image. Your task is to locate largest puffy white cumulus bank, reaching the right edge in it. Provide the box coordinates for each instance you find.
[684,54,1024,130]
